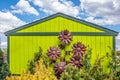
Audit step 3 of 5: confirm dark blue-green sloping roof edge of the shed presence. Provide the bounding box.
[5,12,118,36]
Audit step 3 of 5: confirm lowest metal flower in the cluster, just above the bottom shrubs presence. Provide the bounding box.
[54,62,66,79]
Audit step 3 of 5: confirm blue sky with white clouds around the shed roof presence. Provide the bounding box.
[0,0,120,50]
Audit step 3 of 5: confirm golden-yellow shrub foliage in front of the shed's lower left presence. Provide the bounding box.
[6,59,57,80]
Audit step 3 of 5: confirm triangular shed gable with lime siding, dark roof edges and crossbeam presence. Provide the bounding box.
[5,13,118,36]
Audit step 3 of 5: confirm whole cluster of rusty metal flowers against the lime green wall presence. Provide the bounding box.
[47,30,86,79]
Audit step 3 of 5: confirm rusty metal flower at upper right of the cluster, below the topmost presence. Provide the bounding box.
[72,42,86,56]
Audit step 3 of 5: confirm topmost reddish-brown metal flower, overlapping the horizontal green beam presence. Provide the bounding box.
[58,30,72,44]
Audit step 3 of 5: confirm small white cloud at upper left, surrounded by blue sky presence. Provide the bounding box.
[11,0,39,16]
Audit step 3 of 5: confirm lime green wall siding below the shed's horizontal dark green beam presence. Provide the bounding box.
[10,36,113,74]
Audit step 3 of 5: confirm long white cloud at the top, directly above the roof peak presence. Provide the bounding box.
[29,0,79,16]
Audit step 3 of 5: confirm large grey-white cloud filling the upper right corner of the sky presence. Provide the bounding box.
[80,0,120,25]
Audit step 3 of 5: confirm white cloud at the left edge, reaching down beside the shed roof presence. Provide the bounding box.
[0,11,25,48]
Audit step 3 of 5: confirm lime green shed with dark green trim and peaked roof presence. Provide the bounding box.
[5,13,118,74]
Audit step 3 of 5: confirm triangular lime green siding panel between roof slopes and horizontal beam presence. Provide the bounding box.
[18,17,104,32]
